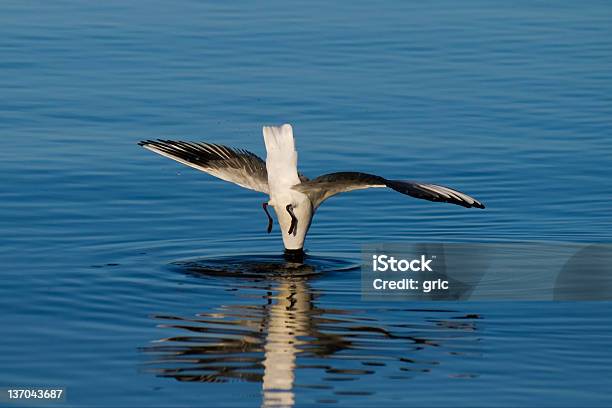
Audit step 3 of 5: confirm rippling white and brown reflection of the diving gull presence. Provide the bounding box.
[143,260,479,407]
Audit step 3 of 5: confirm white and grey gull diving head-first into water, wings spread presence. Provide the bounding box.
[138,124,485,259]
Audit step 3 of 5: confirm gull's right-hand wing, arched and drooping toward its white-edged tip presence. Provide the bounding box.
[292,172,485,208]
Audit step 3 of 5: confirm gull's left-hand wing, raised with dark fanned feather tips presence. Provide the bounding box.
[138,140,269,194]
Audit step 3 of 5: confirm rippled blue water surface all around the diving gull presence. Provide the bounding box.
[0,1,612,407]
